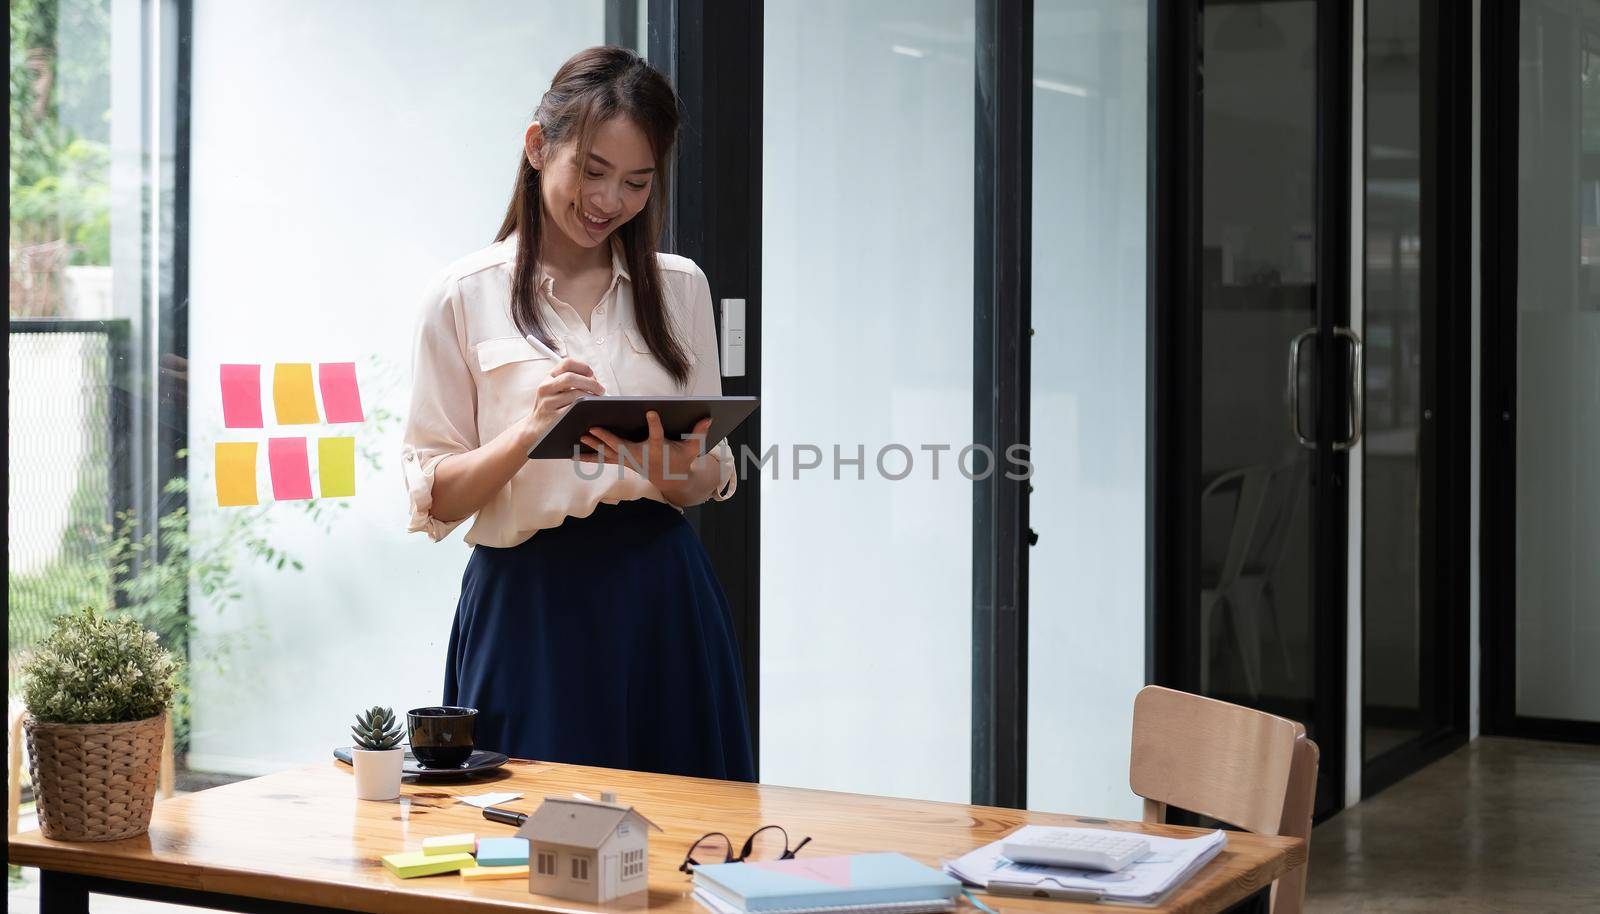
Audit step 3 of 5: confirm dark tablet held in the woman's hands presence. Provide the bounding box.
[528,397,762,459]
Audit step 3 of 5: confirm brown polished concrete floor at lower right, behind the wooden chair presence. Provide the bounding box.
[1306,738,1600,914]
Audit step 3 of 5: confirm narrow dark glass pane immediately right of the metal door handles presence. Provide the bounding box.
[1360,0,1445,760]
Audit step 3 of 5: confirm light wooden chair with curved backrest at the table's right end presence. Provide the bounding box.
[1128,685,1317,914]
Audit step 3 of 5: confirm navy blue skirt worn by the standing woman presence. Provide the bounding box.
[445,499,755,781]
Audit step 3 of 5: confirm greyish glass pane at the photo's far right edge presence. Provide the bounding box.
[1517,0,1600,720]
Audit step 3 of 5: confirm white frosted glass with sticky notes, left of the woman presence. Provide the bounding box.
[187,0,605,773]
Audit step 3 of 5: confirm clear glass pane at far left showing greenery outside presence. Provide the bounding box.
[6,0,168,745]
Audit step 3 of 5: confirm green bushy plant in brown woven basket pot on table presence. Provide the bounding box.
[21,607,178,840]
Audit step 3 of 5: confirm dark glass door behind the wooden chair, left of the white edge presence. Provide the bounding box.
[1192,0,1354,812]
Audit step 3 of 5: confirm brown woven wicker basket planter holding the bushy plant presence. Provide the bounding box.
[24,714,166,840]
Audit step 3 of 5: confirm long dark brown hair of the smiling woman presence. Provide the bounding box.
[494,48,690,384]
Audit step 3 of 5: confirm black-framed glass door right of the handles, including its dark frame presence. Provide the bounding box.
[1352,0,1470,794]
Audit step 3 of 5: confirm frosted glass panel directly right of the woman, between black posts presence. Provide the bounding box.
[761,0,973,800]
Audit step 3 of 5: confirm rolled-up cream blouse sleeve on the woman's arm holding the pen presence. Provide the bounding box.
[400,274,478,543]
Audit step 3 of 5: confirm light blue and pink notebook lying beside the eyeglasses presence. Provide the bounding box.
[694,853,962,912]
